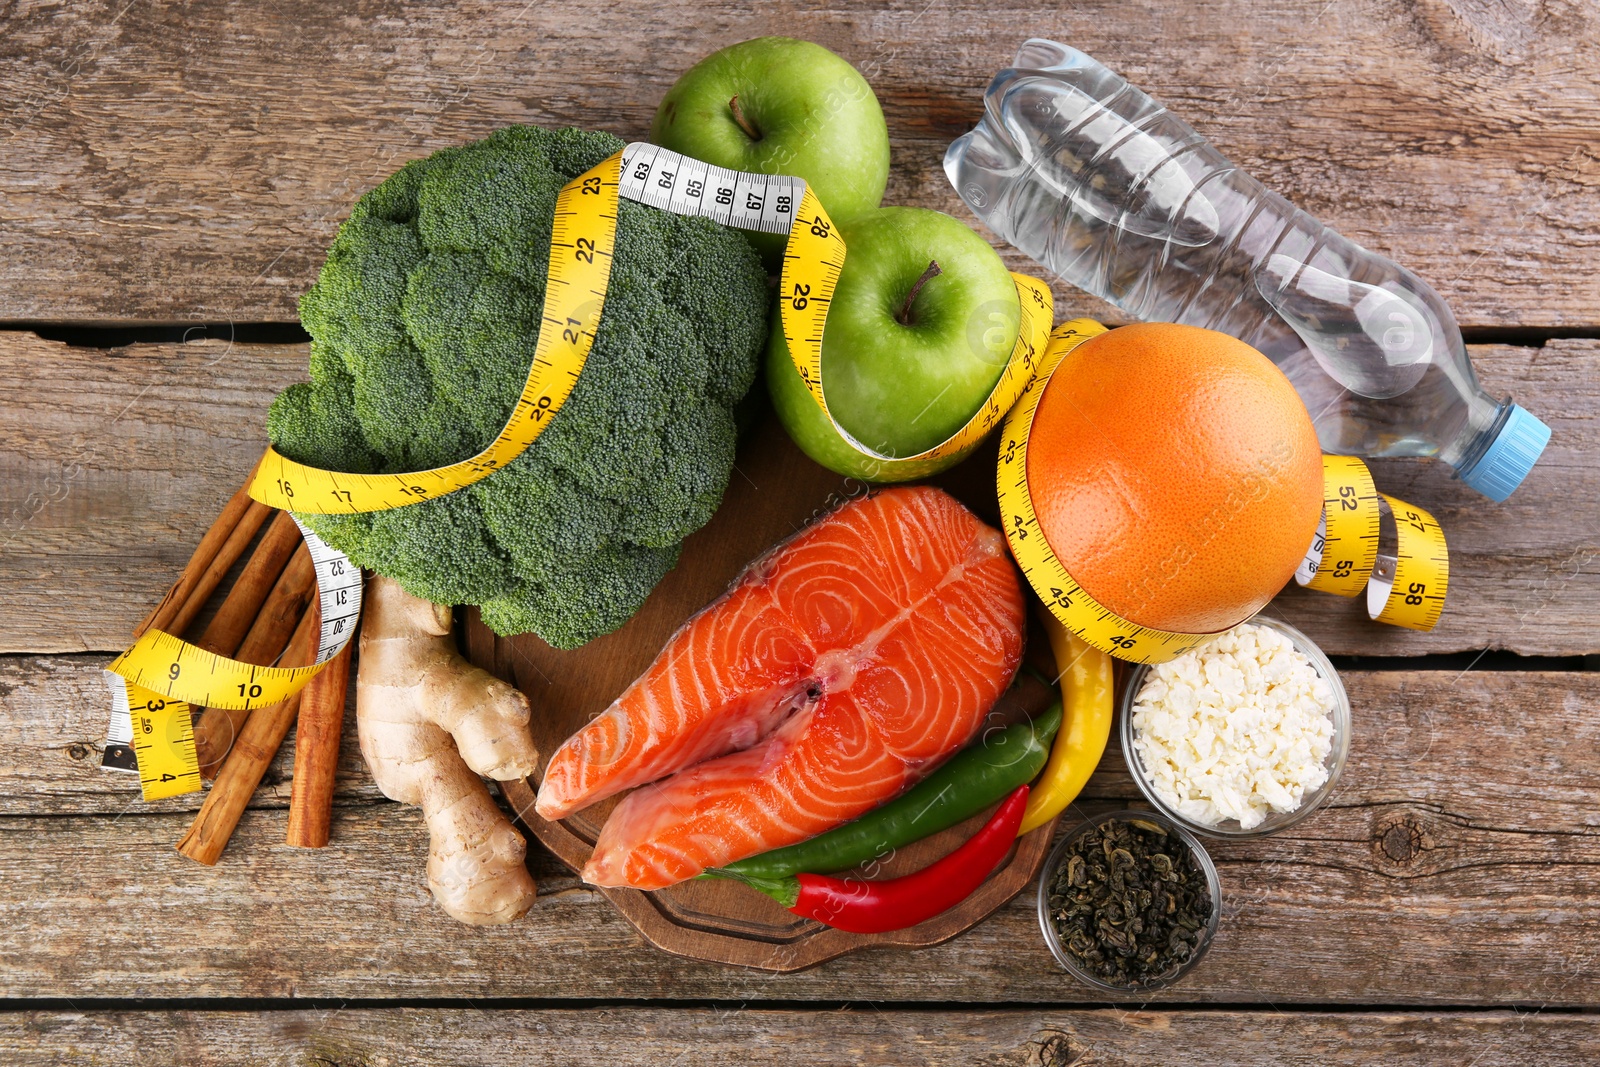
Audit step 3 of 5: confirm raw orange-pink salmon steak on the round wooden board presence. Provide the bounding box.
[536,486,1026,889]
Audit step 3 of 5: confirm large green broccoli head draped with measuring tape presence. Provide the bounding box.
[267,126,768,648]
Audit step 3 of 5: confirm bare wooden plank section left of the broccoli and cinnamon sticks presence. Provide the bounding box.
[0,333,306,651]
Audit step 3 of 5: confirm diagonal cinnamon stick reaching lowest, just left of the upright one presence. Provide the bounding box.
[178,603,322,867]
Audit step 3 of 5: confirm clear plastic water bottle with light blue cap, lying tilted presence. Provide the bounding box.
[944,38,1550,501]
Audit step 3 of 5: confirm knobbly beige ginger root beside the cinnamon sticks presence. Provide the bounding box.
[355,576,539,925]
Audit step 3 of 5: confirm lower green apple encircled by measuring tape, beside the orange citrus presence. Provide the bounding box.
[766,208,1021,482]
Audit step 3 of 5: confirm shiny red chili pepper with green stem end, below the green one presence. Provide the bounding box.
[732,785,1027,934]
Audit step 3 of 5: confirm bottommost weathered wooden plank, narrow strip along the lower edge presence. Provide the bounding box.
[0,1008,1600,1067]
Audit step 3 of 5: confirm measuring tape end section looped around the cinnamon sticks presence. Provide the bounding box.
[106,520,362,800]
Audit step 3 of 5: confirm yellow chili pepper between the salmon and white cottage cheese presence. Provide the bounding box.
[1018,611,1114,837]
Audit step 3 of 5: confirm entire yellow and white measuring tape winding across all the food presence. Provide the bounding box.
[107,137,1445,800]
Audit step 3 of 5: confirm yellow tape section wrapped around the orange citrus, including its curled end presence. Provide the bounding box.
[997,318,1450,664]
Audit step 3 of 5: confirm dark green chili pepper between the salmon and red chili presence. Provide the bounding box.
[706,701,1061,878]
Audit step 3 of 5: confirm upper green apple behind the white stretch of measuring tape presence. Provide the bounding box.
[650,37,890,270]
